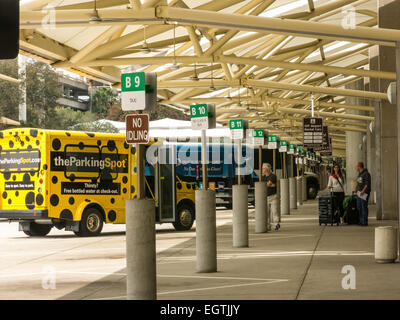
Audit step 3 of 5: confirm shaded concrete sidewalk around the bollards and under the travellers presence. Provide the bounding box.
[62,201,400,300]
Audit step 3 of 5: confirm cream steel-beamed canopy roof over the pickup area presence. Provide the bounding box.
[20,0,400,153]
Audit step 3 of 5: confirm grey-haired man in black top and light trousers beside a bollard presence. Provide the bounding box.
[262,163,280,230]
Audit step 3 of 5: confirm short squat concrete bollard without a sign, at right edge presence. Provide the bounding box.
[375,226,397,263]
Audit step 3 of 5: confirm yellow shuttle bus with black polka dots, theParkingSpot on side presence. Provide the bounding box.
[0,128,197,236]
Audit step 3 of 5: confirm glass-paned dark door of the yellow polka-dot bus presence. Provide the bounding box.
[156,145,176,222]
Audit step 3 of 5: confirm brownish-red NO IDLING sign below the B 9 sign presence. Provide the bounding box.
[125,114,149,144]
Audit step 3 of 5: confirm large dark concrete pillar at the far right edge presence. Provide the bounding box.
[369,0,400,219]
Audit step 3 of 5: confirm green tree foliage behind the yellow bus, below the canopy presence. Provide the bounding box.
[0,59,189,132]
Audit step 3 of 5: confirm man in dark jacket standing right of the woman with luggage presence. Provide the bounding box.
[355,162,371,226]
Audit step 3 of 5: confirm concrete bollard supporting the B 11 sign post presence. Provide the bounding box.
[232,184,249,248]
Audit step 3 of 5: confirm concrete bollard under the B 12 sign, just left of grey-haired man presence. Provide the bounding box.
[254,182,269,233]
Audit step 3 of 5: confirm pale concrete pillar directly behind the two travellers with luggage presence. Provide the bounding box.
[346,79,365,194]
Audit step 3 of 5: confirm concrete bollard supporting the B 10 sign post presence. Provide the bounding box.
[196,190,217,272]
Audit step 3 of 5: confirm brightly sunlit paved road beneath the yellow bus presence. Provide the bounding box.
[0,210,231,300]
